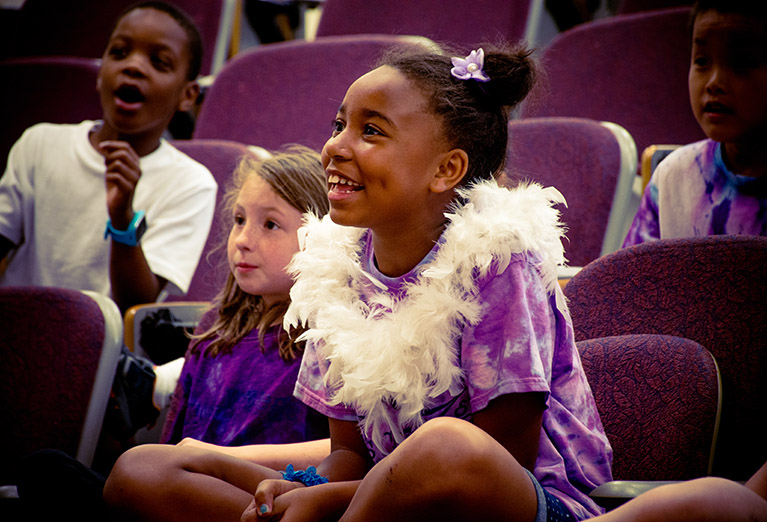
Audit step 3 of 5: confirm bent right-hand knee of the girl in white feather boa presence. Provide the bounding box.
[341,417,537,522]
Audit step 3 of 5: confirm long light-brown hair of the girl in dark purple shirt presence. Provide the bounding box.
[191,145,329,361]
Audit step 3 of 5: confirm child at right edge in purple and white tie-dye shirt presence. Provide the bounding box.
[623,0,767,246]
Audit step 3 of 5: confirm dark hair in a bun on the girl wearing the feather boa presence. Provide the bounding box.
[379,45,536,184]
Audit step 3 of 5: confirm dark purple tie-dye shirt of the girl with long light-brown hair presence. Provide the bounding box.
[162,326,327,446]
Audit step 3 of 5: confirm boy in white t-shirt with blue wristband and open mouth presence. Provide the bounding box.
[0,2,217,311]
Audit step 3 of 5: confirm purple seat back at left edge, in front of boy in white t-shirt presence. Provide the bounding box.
[0,287,123,485]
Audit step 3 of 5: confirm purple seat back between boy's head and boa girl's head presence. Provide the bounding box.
[194,35,433,151]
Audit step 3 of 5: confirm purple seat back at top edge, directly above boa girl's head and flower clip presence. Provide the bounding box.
[317,0,533,47]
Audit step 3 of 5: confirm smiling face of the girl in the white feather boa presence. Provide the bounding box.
[322,67,456,235]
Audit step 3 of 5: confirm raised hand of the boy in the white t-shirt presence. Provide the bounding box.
[99,140,141,226]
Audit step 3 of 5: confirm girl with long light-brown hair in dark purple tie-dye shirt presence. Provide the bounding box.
[162,147,328,446]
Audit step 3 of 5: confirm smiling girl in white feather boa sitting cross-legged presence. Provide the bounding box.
[105,41,612,522]
